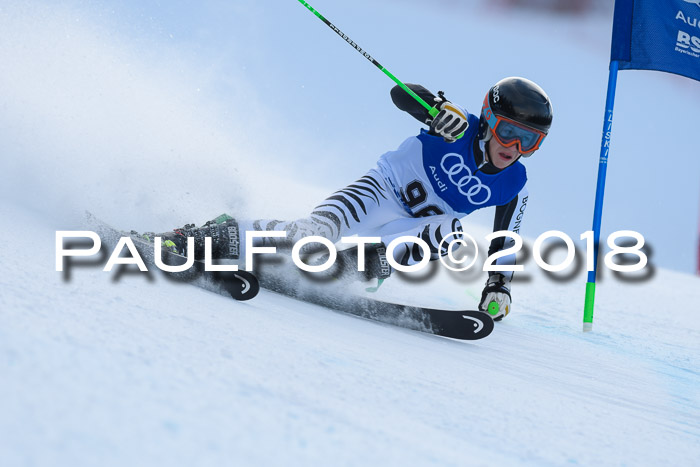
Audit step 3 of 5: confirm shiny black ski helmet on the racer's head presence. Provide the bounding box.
[479,76,552,150]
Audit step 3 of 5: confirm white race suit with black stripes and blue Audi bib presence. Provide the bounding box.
[241,85,528,276]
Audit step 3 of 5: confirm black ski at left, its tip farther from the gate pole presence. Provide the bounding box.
[86,212,260,301]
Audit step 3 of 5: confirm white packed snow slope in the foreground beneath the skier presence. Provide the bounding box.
[0,191,700,466]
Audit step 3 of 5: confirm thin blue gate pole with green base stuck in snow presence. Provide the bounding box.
[583,60,618,332]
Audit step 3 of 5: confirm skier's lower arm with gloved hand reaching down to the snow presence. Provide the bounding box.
[479,187,528,321]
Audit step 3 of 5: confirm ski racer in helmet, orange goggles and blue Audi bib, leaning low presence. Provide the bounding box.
[153,77,552,320]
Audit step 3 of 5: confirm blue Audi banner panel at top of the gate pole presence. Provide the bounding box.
[610,0,700,81]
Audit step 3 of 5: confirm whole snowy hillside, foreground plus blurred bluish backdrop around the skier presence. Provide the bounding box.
[0,0,700,466]
